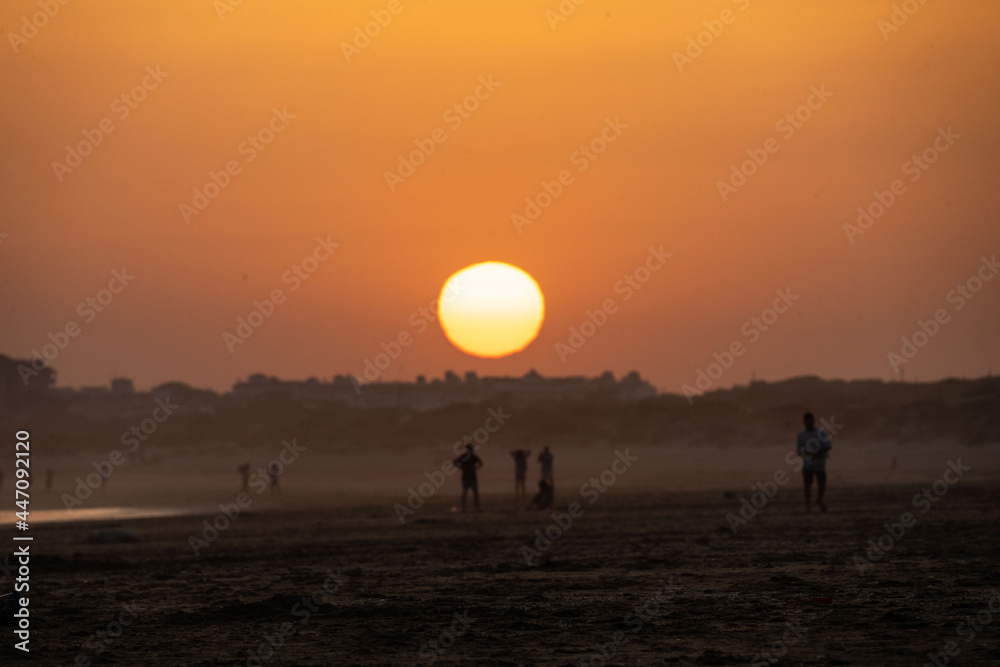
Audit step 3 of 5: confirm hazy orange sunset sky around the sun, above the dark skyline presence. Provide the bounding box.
[0,0,1000,392]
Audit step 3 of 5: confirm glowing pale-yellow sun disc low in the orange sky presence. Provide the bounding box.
[438,262,545,358]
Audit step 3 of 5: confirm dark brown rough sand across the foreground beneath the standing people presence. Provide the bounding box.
[0,479,1000,665]
